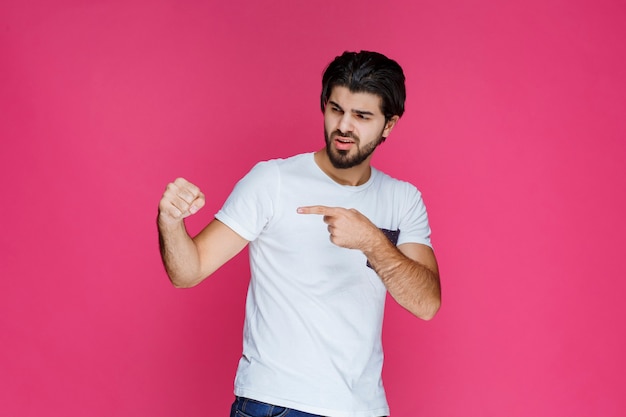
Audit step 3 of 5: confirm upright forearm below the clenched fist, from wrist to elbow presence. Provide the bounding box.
[157,219,202,288]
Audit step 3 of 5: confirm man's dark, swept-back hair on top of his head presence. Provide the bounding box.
[321,51,406,120]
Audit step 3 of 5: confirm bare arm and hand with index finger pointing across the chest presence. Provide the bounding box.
[298,206,441,320]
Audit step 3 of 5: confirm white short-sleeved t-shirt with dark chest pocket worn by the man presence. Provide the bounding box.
[216,153,430,417]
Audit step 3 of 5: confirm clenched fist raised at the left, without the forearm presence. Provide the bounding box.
[159,178,205,225]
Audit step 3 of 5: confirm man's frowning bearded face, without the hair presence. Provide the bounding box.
[324,86,398,169]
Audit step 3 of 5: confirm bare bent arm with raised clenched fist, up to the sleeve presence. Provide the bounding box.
[157,178,248,288]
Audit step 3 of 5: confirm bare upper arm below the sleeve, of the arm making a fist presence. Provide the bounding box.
[193,219,248,277]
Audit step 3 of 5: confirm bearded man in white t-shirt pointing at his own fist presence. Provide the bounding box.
[158,51,440,417]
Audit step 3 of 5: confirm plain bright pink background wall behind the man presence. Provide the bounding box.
[0,0,626,417]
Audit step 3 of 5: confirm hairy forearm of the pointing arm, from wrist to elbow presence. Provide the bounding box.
[364,236,441,320]
